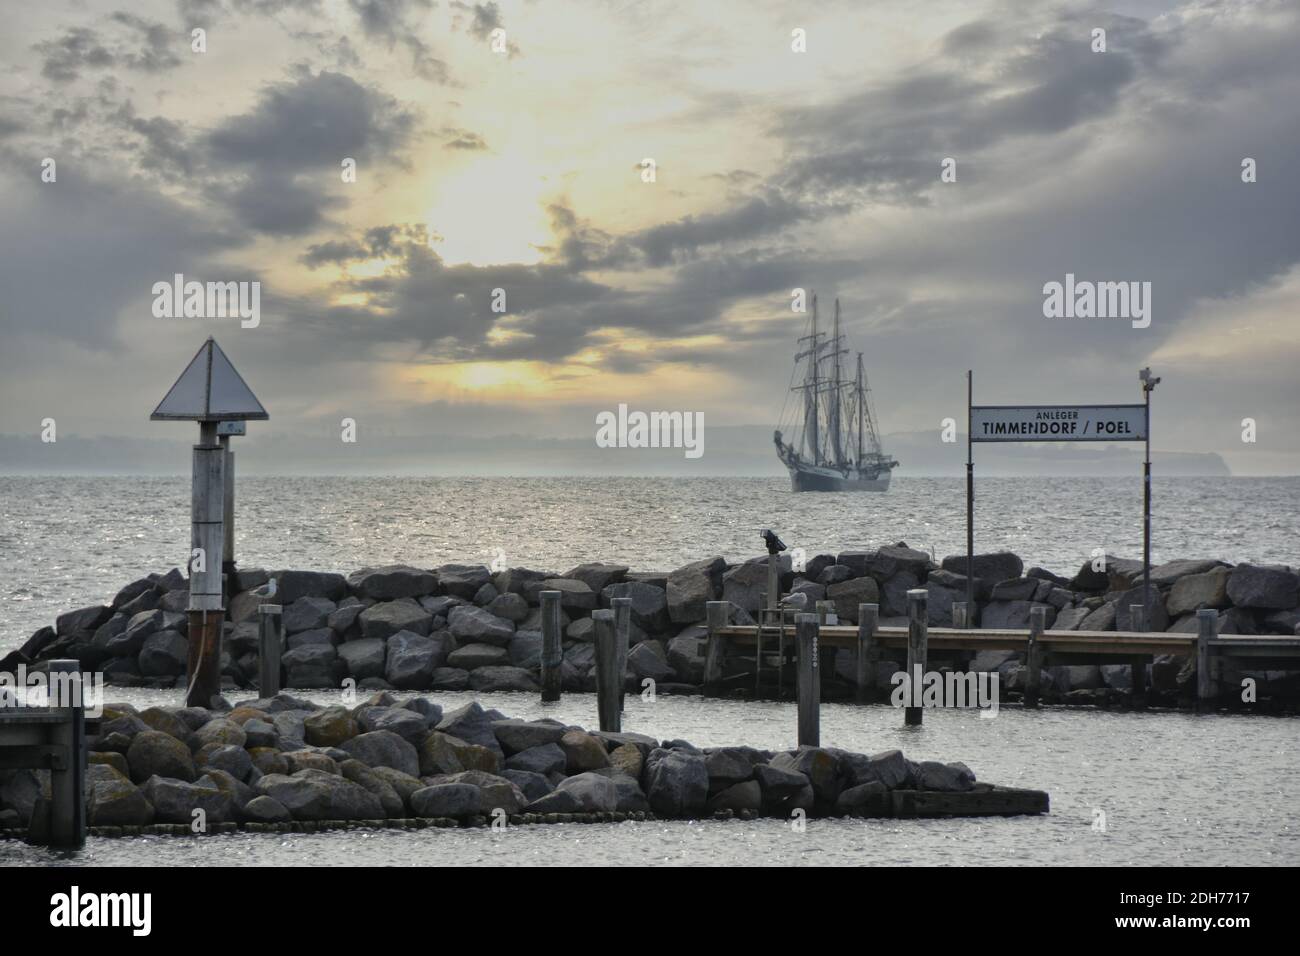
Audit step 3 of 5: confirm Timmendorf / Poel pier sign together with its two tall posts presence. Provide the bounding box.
[966,377,1160,627]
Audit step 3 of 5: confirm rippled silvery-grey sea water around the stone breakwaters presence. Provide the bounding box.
[0,477,1300,865]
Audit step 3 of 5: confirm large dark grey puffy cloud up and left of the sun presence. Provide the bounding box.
[204,70,415,235]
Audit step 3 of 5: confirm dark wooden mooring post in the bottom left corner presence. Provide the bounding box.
[49,661,86,849]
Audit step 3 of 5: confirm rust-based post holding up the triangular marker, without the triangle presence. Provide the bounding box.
[185,421,226,708]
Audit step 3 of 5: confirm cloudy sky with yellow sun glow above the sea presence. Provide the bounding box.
[0,0,1300,473]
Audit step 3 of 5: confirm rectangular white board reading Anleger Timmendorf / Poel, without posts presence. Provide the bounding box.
[970,405,1147,441]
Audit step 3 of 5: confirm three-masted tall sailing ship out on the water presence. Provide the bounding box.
[774,295,898,492]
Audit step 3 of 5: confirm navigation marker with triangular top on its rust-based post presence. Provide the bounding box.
[150,337,269,708]
